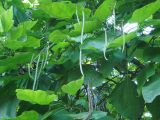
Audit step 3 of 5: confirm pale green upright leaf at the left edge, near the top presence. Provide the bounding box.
[0,7,13,32]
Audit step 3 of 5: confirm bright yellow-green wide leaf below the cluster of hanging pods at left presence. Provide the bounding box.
[16,89,58,105]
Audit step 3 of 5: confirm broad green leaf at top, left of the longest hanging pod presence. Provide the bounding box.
[39,2,76,19]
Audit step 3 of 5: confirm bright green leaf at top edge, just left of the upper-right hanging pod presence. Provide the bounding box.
[93,0,115,21]
